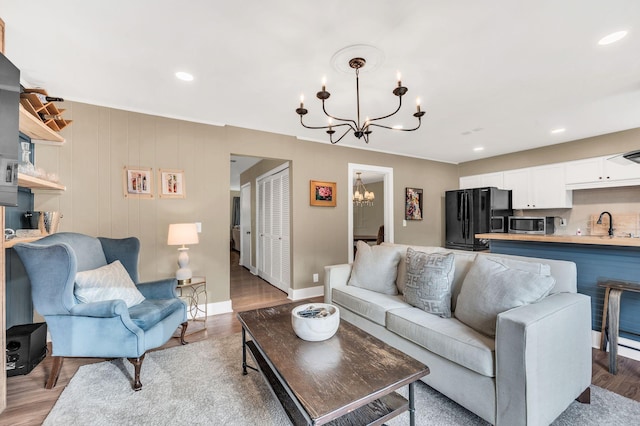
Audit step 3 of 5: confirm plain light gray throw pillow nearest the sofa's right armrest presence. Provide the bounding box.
[454,256,556,337]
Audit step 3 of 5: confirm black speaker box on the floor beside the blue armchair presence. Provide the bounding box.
[6,322,47,377]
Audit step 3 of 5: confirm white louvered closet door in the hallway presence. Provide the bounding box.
[258,169,291,292]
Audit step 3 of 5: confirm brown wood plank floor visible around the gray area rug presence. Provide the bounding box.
[0,252,640,426]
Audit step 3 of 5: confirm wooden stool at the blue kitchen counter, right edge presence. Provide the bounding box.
[598,281,640,374]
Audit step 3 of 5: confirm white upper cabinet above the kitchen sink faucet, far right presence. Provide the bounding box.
[565,155,640,189]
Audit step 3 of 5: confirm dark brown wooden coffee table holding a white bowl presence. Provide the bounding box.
[238,303,429,426]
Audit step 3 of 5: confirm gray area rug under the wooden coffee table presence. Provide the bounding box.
[43,334,640,426]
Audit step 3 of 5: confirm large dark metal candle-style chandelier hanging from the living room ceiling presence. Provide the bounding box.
[296,58,424,144]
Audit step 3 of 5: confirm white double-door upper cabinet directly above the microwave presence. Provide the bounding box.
[504,164,573,210]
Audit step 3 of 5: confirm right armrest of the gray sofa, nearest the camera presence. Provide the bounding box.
[496,293,591,425]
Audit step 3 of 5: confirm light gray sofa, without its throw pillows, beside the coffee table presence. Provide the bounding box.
[324,243,591,426]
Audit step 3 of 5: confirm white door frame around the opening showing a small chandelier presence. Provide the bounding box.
[347,163,393,263]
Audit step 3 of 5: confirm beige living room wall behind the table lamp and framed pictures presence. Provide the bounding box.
[35,102,458,302]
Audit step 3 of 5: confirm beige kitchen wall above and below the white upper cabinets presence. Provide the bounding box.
[459,129,640,235]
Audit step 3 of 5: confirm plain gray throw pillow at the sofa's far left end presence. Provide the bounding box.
[347,241,400,295]
